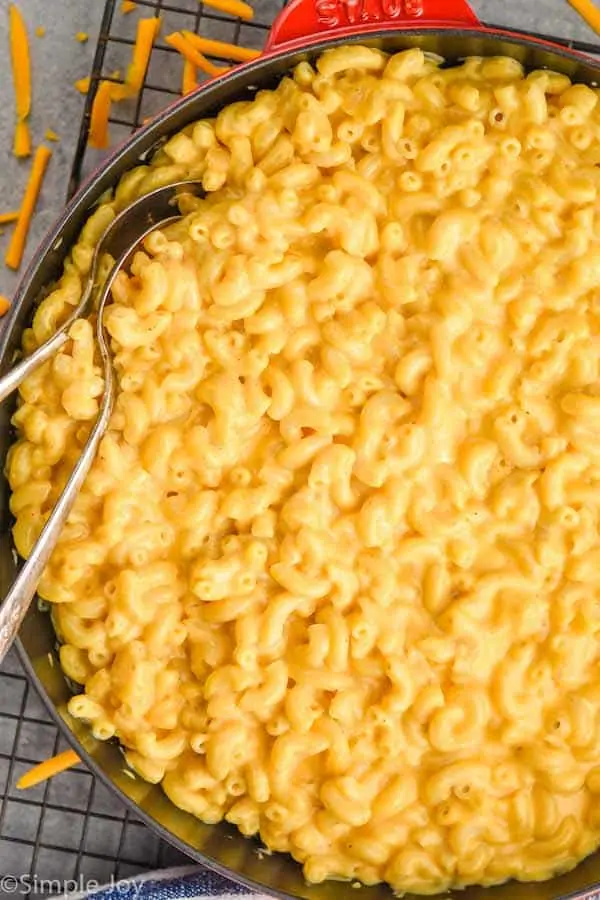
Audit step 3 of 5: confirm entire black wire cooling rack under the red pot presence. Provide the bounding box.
[0,0,598,898]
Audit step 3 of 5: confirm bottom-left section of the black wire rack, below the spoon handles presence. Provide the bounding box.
[0,651,189,884]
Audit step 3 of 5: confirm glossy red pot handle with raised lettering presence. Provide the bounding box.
[265,0,481,51]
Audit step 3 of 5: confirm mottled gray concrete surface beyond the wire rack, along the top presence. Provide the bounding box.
[0,0,600,296]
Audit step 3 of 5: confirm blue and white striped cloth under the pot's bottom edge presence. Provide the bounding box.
[54,866,269,900]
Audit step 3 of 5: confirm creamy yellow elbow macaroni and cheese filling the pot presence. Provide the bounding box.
[8,46,600,894]
